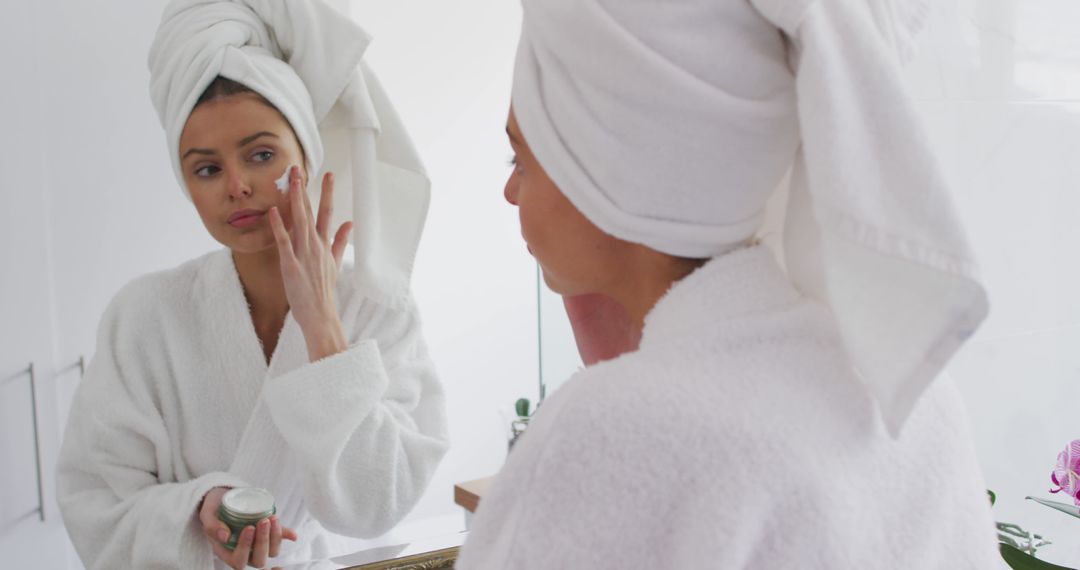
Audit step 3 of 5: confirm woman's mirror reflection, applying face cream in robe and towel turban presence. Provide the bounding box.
[57,0,447,569]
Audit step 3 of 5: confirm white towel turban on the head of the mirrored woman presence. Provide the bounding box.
[149,0,430,304]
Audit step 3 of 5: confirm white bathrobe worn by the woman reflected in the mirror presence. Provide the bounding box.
[57,249,447,570]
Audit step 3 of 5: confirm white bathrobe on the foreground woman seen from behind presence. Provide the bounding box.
[457,246,1000,570]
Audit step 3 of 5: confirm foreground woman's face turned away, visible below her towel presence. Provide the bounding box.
[504,109,634,296]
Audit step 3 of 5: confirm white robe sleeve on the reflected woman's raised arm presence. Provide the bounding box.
[264,293,448,538]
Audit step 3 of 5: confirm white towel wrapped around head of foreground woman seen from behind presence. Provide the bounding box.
[513,0,987,434]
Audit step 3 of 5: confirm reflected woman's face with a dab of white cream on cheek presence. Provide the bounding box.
[180,93,307,254]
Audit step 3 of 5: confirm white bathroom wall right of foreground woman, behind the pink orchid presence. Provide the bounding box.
[909,0,1080,568]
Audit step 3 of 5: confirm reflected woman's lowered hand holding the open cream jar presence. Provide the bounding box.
[199,487,297,570]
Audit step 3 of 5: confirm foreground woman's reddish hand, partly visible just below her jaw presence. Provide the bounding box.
[563,294,642,366]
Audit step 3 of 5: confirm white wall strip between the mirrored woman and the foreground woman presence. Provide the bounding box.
[346,0,539,537]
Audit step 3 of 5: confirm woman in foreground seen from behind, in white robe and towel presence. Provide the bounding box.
[457,0,1000,570]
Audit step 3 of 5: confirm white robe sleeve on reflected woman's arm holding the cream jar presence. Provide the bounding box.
[56,288,246,570]
